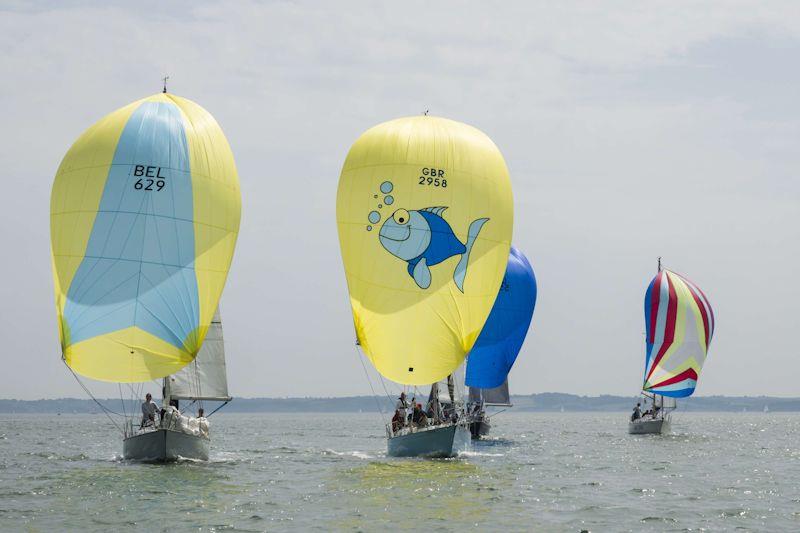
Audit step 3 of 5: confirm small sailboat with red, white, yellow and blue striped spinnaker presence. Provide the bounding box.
[628,257,715,434]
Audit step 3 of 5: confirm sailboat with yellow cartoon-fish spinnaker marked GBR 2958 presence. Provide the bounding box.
[336,115,513,457]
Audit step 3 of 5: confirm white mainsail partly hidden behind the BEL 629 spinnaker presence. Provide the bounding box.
[167,309,231,402]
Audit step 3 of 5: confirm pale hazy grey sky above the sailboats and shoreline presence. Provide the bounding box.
[0,1,800,399]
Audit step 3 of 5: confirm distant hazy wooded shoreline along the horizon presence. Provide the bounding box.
[0,392,800,414]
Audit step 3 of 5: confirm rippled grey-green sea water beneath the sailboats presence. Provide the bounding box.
[0,411,800,532]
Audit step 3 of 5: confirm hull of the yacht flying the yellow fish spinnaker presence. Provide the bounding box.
[387,424,470,458]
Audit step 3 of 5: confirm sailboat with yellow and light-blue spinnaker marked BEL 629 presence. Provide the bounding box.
[50,87,241,461]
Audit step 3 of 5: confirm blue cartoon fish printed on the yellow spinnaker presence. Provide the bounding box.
[378,207,489,293]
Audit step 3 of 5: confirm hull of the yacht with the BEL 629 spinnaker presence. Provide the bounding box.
[122,429,211,462]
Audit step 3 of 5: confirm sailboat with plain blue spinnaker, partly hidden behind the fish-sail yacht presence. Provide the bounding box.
[466,246,536,439]
